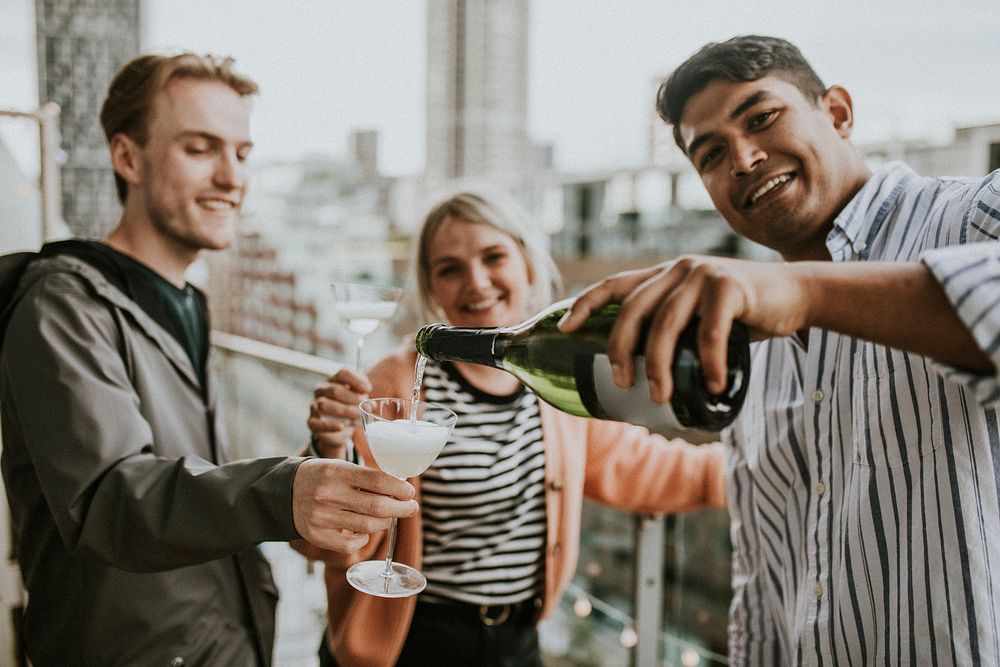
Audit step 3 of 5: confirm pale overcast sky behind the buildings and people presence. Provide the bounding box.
[0,0,1000,174]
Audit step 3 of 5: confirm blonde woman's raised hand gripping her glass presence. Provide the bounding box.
[306,368,372,459]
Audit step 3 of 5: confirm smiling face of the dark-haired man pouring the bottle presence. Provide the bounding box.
[678,75,870,260]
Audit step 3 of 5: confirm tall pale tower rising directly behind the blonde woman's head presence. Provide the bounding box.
[425,0,534,186]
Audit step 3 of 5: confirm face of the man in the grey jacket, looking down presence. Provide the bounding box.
[122,78,252,254]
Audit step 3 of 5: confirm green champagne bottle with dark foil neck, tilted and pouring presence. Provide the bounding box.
[416,300,750,433]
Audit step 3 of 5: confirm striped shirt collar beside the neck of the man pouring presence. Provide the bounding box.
[826,162,916,260]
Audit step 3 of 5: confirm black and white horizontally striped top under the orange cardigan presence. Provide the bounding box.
[420,361,545,604]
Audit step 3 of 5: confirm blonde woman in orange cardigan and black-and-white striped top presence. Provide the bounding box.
[298,191,725,667]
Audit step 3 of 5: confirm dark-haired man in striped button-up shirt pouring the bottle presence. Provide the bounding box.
[563,36,1000,665]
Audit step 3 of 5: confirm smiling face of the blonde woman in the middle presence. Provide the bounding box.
[427,217,531,327]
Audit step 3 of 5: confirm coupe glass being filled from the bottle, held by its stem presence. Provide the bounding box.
[347,398,458,598]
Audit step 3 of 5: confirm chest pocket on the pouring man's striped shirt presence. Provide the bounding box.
[851,343,941,468]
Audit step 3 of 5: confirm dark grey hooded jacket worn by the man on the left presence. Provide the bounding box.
[0,255,302,667]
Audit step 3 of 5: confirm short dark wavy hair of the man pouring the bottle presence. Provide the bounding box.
[656,35,826,150]
